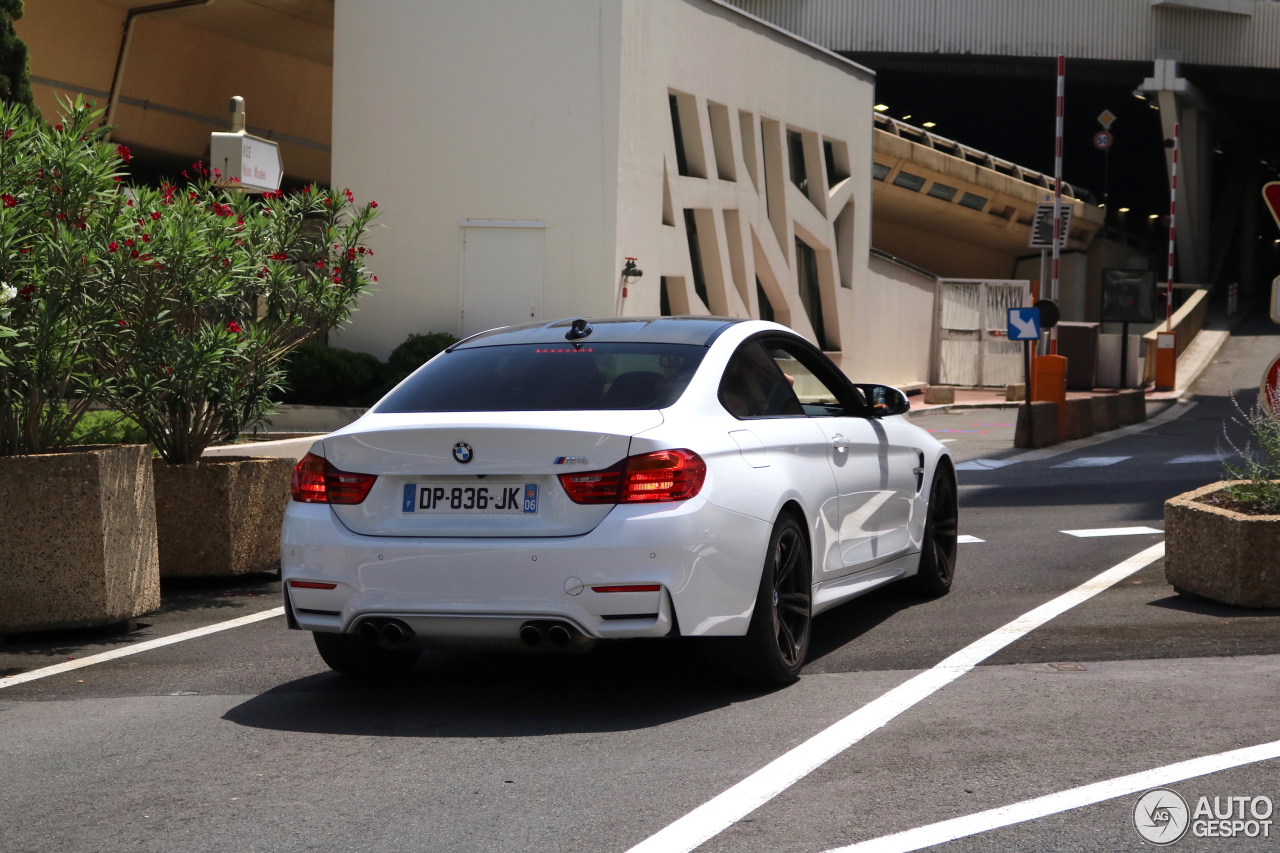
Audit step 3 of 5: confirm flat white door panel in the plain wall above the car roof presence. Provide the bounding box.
[460,220,543,337]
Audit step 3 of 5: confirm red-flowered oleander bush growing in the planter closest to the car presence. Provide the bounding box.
[108,164,375,464]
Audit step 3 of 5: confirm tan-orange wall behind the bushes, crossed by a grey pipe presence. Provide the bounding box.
[17,0,333,182]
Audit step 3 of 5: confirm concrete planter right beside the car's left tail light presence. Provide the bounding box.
[155,456,293,578]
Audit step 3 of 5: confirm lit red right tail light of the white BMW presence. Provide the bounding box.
[559,450,707,503]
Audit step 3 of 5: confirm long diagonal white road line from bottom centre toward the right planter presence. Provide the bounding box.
[627,542,1165,853]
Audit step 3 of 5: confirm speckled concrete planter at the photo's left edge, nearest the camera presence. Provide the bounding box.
[0,444,160,634]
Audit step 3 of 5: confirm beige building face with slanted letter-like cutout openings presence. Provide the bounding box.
[611,0,875,373]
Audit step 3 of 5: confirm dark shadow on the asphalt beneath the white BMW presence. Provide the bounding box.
[223,639,762,738]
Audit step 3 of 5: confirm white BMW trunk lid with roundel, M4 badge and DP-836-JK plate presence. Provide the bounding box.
[323,410,662,538]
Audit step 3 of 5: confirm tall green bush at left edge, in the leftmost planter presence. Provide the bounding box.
[0,100,124,456]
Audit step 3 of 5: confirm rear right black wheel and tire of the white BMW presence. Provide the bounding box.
[722,515,813,688]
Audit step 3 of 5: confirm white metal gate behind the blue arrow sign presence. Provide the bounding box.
[936,278,1032,387]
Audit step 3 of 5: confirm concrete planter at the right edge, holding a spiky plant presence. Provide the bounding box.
[1165,480,1280,607]
